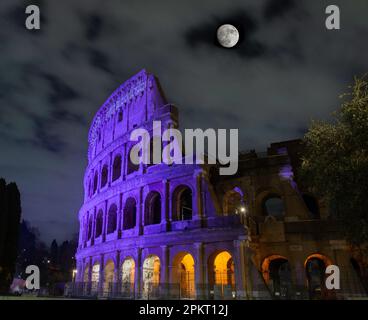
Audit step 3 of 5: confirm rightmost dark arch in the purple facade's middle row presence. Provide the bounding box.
[172,185,193,221]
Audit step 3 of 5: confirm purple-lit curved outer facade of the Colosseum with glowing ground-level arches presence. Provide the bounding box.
[76,70,247,297]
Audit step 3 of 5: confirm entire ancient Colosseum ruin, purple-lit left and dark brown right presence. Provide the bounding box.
[72,70,364,299]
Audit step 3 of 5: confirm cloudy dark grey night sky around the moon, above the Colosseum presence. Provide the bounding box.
[0,0,368,241]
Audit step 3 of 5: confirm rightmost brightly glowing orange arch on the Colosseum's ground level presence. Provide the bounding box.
[208,250,235,299]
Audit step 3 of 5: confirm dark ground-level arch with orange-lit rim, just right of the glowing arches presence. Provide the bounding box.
[261,254,292,298]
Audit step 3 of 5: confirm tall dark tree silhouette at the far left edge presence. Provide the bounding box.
[0,179,21,293]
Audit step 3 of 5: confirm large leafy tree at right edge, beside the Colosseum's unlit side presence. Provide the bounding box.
[301,76,368,248]
